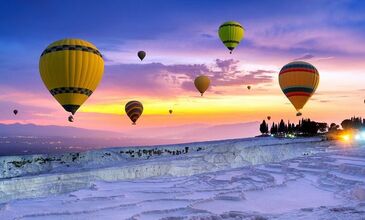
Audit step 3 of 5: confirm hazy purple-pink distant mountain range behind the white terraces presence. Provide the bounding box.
[0,122,259,155]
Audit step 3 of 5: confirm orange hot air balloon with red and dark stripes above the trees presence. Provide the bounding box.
[279,61,319,116]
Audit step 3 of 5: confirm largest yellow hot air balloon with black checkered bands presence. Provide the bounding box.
[39,39,104,114]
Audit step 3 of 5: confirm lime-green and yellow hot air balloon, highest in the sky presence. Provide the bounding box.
[218,21,245,53]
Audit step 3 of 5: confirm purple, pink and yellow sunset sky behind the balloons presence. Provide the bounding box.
[0,0,365,136]
